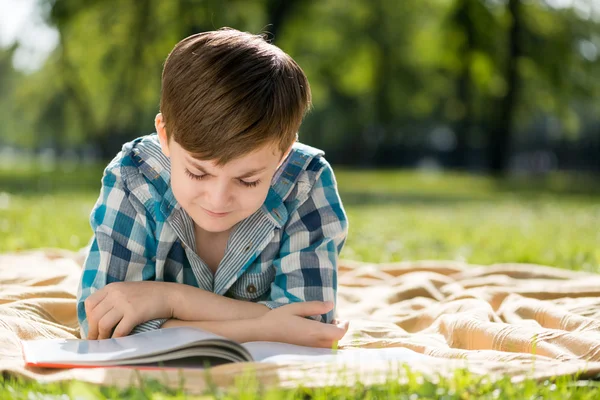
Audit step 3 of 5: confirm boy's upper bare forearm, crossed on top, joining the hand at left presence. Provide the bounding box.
[166,283,270,321]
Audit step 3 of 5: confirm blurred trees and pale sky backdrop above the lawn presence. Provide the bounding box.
[0,0,600,172]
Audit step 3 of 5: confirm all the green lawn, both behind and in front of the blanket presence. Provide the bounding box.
[0,163,600,399]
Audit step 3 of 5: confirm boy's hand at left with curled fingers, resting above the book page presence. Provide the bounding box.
[84,281,173,340]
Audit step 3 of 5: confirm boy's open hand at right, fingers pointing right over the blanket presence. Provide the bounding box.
[258,301,348,348]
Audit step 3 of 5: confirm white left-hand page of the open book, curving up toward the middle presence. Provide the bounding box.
[23,327,232,364]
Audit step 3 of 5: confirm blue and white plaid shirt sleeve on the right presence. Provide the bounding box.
[260,159,348,323]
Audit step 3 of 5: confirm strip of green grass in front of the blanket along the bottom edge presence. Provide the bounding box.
[0,367,600,400]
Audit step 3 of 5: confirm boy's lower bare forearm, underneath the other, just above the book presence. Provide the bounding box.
[162,319,270,343]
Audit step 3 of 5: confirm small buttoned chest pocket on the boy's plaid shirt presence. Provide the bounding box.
[227,264,275,301]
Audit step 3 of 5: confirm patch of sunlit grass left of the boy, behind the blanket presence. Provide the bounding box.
[0,162,102,251]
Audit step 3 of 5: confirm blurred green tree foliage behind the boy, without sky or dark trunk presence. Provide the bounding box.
[0,0,600,162]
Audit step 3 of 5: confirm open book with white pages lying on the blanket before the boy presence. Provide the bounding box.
[21,327,433,368]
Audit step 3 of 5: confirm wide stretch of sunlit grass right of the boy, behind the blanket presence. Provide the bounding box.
[338,171,600,272]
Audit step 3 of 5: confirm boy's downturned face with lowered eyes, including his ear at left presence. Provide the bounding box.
[156,114,284,233]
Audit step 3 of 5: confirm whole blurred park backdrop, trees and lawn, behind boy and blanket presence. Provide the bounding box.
[0,0,600,270]
